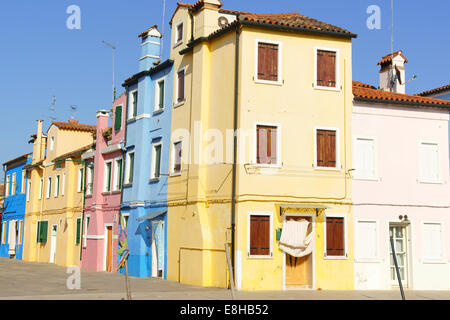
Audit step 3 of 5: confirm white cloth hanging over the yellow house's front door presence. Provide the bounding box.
[279,219,313,258]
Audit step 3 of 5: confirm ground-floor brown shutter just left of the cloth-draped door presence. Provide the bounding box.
[250,215,270,255]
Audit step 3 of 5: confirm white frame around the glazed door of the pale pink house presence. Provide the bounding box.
[387,220,413,289]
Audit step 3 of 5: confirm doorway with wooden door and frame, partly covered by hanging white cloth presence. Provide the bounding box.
[284,214,315,289]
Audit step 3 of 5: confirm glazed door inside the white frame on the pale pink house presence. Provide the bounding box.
[388,224,408,287]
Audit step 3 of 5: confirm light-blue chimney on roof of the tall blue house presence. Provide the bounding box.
[139,25,162,72]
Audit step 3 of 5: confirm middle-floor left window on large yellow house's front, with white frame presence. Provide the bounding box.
[256,124,280,165]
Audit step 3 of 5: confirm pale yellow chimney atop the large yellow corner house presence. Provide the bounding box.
[193,0,222,38]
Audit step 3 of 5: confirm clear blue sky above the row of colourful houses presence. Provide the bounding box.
[0,0,450,176]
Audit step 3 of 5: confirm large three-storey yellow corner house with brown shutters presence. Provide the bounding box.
[167,0,356,290]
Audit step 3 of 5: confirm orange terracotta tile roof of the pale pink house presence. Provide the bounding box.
[353,81,450,108]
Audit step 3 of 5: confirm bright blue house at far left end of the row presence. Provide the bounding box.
[0,153,32,259]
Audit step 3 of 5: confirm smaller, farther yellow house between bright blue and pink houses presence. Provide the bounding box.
[23,120,96,266]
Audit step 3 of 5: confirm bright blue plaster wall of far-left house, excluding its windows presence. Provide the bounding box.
[0,155,32,260]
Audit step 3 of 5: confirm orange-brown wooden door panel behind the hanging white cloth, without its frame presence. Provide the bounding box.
[286,217,312,286]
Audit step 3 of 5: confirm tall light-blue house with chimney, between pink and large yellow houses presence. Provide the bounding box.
[119,26,173,279]
